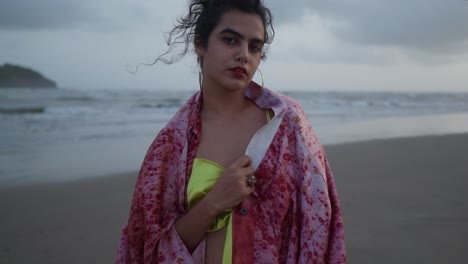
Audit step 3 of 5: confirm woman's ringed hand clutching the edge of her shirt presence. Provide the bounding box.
[205,155,255,212]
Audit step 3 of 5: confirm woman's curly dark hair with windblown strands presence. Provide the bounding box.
[128,0,275,70]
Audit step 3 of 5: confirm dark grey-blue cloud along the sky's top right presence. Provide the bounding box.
[268,0,468,56]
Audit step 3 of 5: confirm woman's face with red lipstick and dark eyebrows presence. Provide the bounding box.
[196,10,265,91]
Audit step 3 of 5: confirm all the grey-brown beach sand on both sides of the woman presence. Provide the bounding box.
[0,134,468,264]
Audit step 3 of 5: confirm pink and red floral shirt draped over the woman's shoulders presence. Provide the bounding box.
[116,83,346,264]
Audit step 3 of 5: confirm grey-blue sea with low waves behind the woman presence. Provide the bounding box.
[0,88,468,187]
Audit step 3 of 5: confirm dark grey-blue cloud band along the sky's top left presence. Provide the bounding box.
[0,0,165,31]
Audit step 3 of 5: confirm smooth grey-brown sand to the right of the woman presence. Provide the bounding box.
[326,134,468,264]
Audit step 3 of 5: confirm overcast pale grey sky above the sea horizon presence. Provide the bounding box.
[0,0,468,92]
